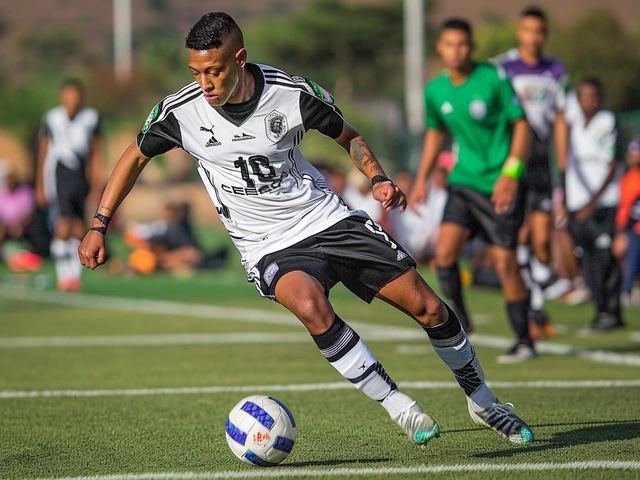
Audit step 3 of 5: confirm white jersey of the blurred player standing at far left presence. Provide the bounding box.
[40,105,100,200]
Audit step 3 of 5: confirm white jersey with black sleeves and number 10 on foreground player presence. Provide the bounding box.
[138,64,366,281]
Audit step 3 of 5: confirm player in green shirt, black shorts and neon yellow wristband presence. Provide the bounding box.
[409,19,536,363]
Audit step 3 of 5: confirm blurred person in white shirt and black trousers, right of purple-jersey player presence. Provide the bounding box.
[558,78,623,332]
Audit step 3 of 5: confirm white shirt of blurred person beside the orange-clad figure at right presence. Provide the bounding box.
[565,106,622,212]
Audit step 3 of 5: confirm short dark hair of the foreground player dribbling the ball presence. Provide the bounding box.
[185,12,244,50]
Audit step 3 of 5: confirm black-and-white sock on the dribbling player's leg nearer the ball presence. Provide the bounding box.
[312,315,413,418]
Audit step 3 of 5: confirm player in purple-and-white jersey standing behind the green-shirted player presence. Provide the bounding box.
[493,7,571,337]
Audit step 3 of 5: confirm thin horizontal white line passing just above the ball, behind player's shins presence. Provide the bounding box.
[0,380,640,400]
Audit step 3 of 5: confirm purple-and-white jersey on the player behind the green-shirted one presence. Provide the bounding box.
[492,48,569,142]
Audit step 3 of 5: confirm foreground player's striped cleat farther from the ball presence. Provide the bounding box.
[467,397,533,445]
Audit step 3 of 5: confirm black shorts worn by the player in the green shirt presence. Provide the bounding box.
[442,185,524,249]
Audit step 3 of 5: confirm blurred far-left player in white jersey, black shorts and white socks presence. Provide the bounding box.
[36,79,103,291]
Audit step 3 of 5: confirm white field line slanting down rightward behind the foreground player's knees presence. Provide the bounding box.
[0,285,640,367]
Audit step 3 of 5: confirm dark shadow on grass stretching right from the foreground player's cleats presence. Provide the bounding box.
[474,420,640,458]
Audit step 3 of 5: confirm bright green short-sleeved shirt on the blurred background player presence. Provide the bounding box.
[425,63,525,193]
